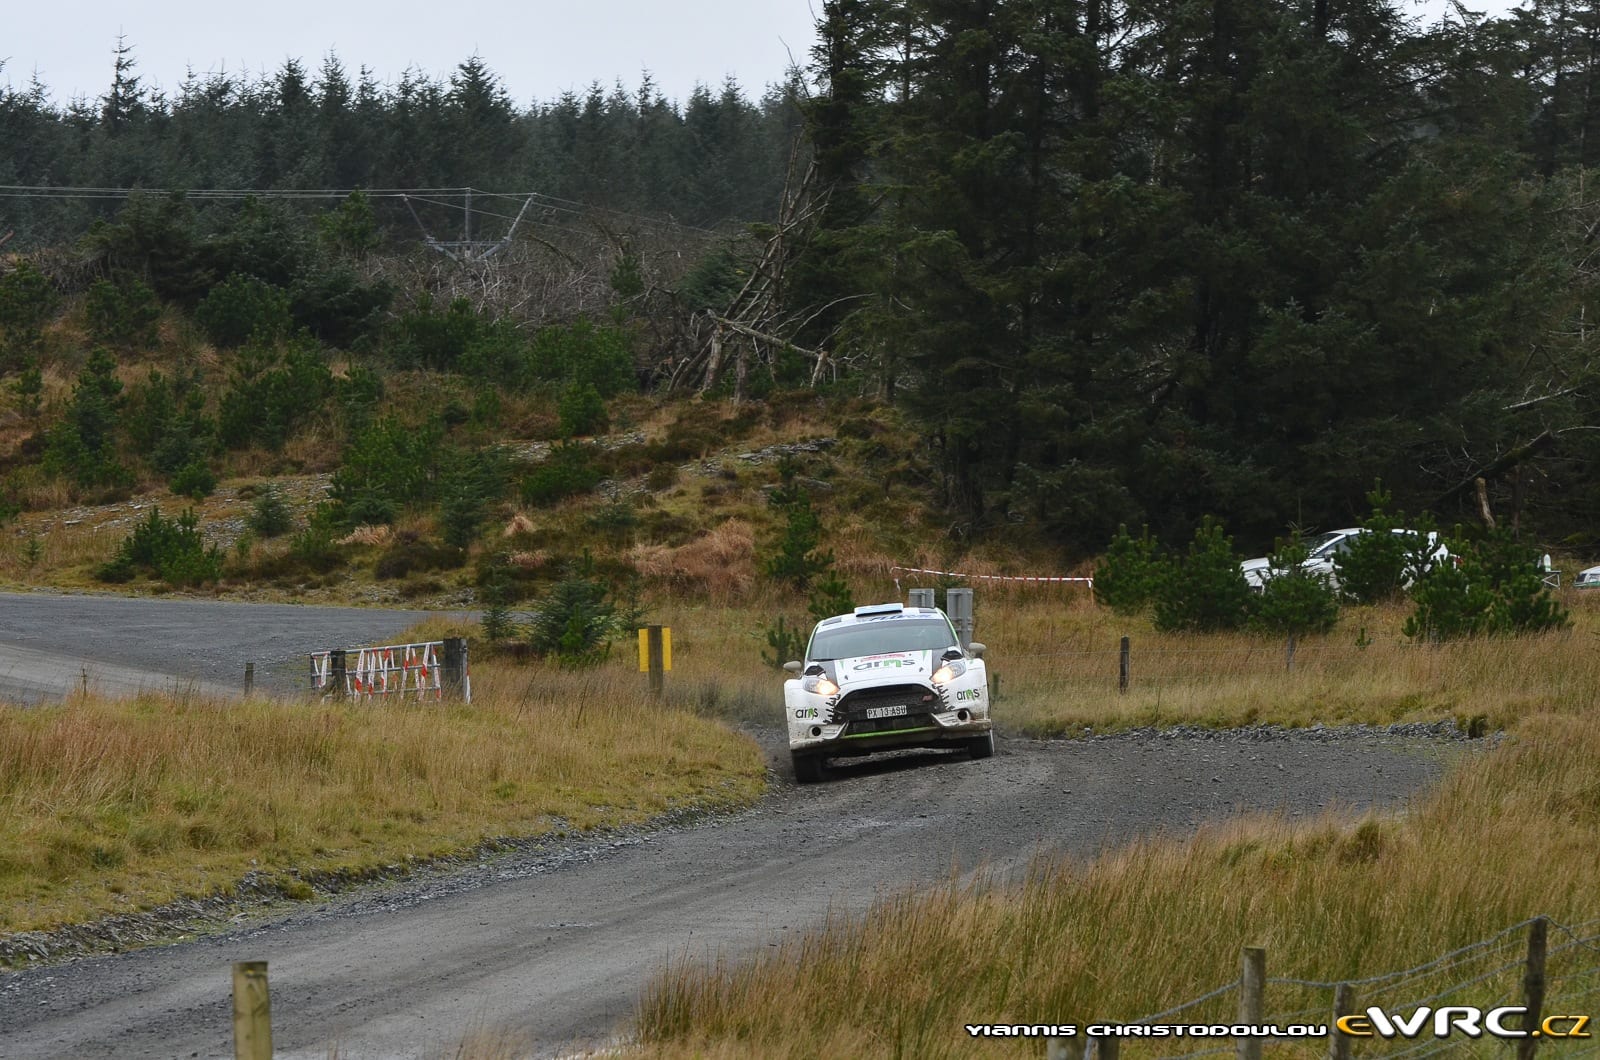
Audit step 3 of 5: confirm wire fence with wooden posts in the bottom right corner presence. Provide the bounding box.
[1046,916,1600,1060]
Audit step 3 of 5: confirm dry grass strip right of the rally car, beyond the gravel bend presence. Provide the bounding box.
[978,589,1600,735]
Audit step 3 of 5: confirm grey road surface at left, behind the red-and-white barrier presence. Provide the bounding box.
[0,592,444,703]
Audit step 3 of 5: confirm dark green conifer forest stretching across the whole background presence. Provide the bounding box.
[0,0,1600,557]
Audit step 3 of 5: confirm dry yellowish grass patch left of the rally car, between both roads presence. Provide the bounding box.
[0,665,763,932]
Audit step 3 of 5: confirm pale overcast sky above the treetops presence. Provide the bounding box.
[0,0,1512,107]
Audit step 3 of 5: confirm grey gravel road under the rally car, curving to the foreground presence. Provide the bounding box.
[0,725,1472,1060]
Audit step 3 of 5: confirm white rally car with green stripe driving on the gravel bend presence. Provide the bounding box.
[784,604,995,783]
